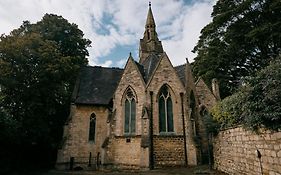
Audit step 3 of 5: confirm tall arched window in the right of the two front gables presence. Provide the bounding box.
[158,85,174,132]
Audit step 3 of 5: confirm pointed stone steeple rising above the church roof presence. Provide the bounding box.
[139,2,164,64]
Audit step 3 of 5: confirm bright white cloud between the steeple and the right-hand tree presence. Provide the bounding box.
[162,1,213,65]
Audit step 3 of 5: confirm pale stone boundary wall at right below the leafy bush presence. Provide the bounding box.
[213,127,281,175]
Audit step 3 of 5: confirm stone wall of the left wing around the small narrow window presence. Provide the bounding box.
[57,105,108,169]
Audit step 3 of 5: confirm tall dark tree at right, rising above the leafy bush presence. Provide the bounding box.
[193,0,281,97]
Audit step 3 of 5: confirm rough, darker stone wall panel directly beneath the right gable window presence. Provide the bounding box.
[153,136,185,168]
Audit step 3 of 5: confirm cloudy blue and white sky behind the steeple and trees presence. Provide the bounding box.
[0,0,216,67]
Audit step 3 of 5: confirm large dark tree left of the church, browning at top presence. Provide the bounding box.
[0,14,91,171]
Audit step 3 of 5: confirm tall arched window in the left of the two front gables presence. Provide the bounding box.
[124,88,136,134]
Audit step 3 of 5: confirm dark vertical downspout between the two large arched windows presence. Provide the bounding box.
[149,91,154,170]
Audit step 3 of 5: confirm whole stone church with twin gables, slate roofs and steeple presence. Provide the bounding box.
[57,6,220,169]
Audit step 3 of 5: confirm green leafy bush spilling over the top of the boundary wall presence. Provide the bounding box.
[211,56,281,130]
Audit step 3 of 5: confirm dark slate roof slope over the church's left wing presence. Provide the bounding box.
[72,66,123,105]
